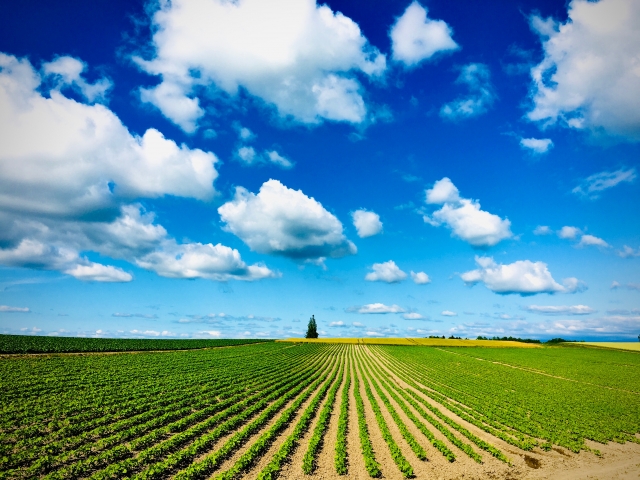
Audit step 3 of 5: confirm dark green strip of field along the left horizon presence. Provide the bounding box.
[0,335,273,353]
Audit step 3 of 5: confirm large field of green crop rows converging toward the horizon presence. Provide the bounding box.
[0,342,640,480]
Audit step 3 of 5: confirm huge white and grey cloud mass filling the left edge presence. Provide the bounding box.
[0,54,272,288]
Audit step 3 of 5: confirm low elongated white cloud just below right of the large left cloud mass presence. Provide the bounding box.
[136,241,279,281]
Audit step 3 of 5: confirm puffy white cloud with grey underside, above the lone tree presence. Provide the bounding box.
[218,180,357,260]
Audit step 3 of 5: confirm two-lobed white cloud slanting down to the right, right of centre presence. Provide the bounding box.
[423,177,513,248]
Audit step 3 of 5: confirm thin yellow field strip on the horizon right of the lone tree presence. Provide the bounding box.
[276,338,541,348]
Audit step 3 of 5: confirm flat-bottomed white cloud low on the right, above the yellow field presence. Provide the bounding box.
[460,256,585,296]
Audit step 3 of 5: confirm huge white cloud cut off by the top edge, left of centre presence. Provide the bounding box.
[134,0,386,131]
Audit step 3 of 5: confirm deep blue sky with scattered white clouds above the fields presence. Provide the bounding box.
[0,0,640,340]
